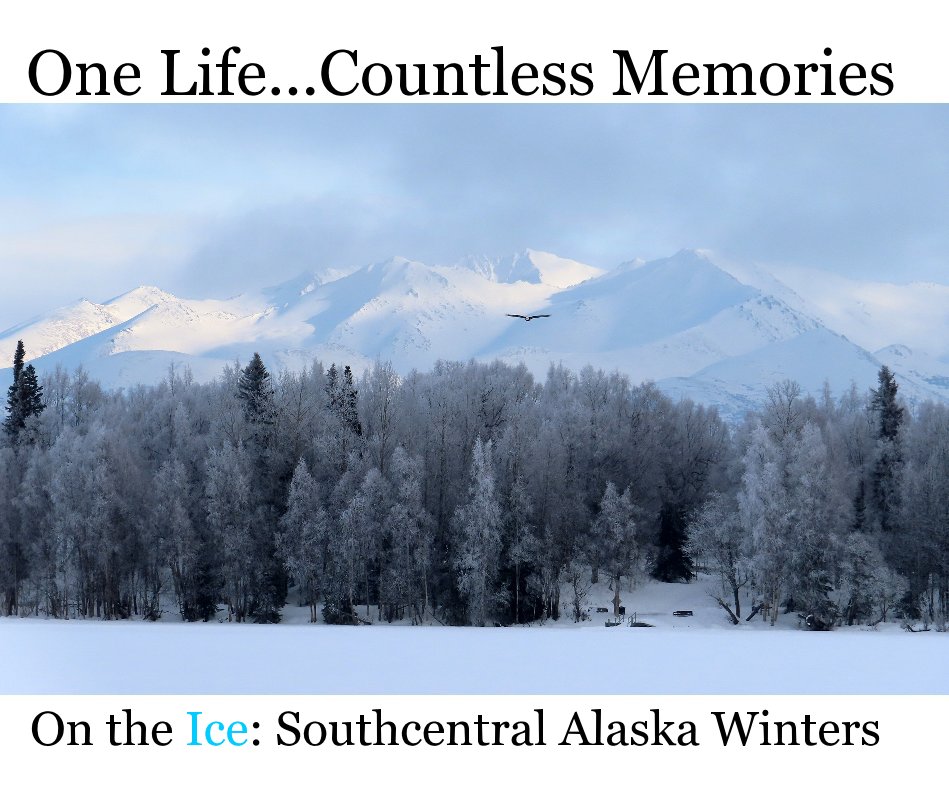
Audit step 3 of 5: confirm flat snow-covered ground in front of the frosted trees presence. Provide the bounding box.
[0,582,949,694]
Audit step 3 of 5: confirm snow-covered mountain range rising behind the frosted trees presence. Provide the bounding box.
[0,250,949,412]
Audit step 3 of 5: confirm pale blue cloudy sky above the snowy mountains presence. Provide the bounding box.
[0,104,949,330]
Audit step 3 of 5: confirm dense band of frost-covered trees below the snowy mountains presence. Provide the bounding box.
[0,334,949,628]
